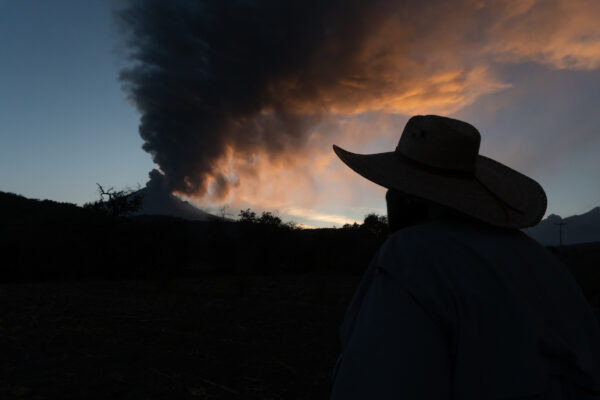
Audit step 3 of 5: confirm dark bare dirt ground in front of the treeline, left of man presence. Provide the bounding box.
[0,275,360,400]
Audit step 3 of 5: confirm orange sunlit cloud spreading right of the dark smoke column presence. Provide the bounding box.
[176,0,600,225]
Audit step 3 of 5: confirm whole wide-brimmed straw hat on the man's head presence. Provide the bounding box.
[333,115,547,228]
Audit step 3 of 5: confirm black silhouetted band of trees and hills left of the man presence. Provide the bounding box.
[0,191,387,282]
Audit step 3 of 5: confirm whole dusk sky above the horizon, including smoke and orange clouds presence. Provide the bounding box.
[0,0,600,226]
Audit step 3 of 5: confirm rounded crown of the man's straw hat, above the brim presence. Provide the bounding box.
[396,115,481,174]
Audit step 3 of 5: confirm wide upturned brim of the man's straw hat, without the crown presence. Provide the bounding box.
[333,145,547,229]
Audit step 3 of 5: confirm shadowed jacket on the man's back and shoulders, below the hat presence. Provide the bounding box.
[331,218,600,400]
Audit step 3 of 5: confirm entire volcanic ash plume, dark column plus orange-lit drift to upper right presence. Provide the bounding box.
[116,0,598,206]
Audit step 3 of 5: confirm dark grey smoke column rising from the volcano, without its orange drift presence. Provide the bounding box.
[118,0,380,198]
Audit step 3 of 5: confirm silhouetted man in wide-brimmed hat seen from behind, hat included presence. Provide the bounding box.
[331,115,600,400]
